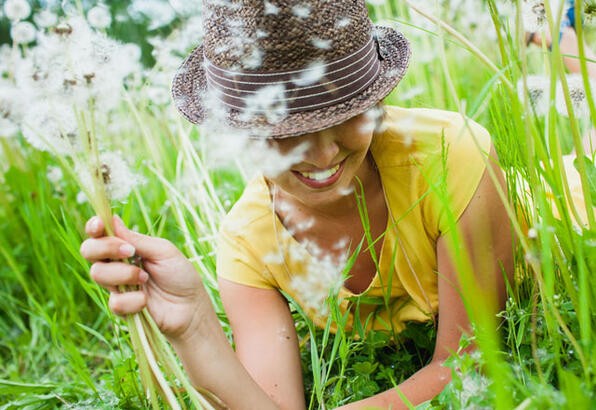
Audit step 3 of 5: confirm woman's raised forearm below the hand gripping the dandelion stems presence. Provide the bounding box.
[170,306,277,409]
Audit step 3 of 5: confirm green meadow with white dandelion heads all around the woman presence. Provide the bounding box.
[0,0,596,410]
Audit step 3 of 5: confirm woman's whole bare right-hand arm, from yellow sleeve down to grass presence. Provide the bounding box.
[341,148,513,410]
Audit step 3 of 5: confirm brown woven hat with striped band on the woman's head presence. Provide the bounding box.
[172,0,410,138]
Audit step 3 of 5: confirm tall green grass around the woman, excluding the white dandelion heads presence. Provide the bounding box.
[0,0,596,409]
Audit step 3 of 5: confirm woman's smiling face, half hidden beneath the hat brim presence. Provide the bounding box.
[269,114,374,207]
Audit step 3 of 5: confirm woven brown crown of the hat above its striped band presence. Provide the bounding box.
[203,0,372,73]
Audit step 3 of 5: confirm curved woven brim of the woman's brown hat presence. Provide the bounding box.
[172,26,411,138]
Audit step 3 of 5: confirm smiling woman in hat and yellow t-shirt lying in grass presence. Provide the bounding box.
[81,1,512,409]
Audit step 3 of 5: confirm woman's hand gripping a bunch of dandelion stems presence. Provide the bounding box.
[81,216,205,339]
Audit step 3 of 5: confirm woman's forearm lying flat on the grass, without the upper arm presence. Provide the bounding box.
[340,361,451,410]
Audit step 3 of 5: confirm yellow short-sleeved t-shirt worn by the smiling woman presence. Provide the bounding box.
[217,107,491,333]
